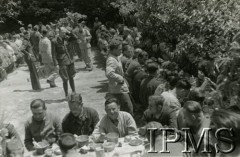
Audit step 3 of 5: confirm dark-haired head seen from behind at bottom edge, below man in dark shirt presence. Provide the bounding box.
[58,133,80,157]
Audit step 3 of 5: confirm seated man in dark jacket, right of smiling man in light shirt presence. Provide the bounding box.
[142,95,177,128]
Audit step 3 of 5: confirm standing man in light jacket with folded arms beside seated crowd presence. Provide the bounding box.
[106,37,133,115]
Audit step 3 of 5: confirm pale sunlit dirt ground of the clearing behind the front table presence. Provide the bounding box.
[0,47,107,140]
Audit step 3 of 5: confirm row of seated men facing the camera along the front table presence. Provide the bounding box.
[1,93,240,156]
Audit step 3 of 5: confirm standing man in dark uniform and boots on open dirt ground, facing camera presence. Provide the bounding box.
[52,27,76,97]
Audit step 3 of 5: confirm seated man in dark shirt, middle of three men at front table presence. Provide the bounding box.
[62,93,99,135]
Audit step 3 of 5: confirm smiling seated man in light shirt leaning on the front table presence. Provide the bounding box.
[93,98,137,139]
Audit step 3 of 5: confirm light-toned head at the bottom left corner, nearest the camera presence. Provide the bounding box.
[6,139,24,157]
